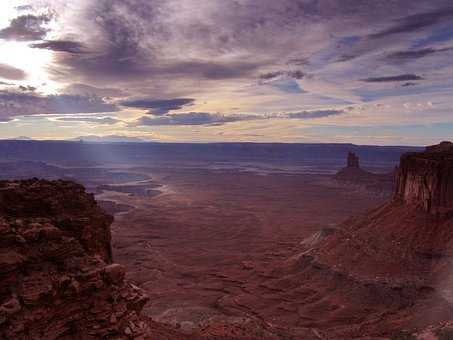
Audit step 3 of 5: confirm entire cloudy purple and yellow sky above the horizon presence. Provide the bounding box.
[0,0,453,145]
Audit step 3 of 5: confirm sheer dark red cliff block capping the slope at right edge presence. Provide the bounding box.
[395,142,453,216]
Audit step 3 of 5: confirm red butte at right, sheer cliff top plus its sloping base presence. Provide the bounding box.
[292,143,453,339]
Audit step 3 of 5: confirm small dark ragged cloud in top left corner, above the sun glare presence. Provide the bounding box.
[0,14,50,41]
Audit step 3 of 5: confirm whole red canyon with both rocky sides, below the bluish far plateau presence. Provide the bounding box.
[0,142,453,339]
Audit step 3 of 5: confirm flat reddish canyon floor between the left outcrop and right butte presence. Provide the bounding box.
[106,169,385,334]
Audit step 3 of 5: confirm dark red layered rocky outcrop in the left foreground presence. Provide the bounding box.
[0,179,149,340]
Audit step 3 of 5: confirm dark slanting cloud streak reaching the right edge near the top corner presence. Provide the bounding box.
[369,6,453,39]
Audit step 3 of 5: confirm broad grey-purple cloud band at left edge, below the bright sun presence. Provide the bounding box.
[0,91,118,121]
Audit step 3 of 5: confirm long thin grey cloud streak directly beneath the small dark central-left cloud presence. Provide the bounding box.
[131,110,345,126]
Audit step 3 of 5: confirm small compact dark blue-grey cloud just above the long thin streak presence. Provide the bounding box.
[120,98,194,116]
